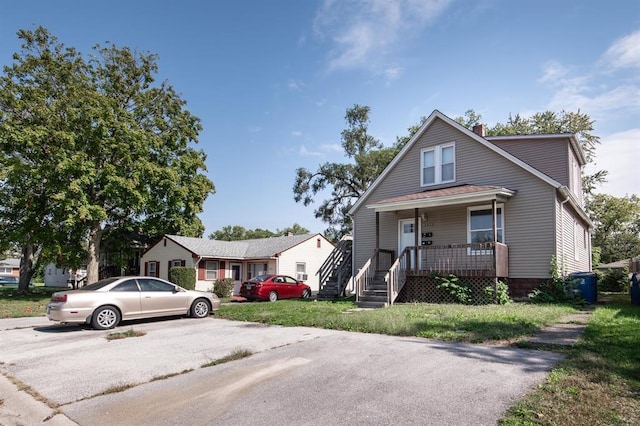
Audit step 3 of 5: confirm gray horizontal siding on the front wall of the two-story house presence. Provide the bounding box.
[354,119,566,278]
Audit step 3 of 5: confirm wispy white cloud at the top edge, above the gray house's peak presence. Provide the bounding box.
[313,0,451,72]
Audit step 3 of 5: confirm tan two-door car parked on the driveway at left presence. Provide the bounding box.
[47,277,220,330]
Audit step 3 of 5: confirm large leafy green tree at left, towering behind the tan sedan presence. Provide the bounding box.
[0,27,214,289]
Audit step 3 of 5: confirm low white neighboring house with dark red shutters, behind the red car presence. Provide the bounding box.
[140,234,334,295]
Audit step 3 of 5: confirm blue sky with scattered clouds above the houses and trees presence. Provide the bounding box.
[0,0,640,236]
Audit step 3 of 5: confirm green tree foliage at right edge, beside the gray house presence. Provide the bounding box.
[586,194,640,263]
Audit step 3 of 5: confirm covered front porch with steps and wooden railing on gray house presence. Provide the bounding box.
[355,185,515,306]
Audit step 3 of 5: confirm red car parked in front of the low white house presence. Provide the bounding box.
[240,275,311,302]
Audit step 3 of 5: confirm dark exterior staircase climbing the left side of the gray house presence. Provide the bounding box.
[316,236,353,300]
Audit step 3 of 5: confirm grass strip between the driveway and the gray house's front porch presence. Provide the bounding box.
[216,299,576,343]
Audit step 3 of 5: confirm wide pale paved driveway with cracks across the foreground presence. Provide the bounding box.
[0,318,561,425]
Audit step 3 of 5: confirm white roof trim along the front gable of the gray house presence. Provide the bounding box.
[349,109,588,216]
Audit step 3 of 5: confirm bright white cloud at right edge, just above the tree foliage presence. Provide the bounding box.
[586,128,640,197]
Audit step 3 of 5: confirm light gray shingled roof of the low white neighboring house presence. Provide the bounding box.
[165,234,330,259]
